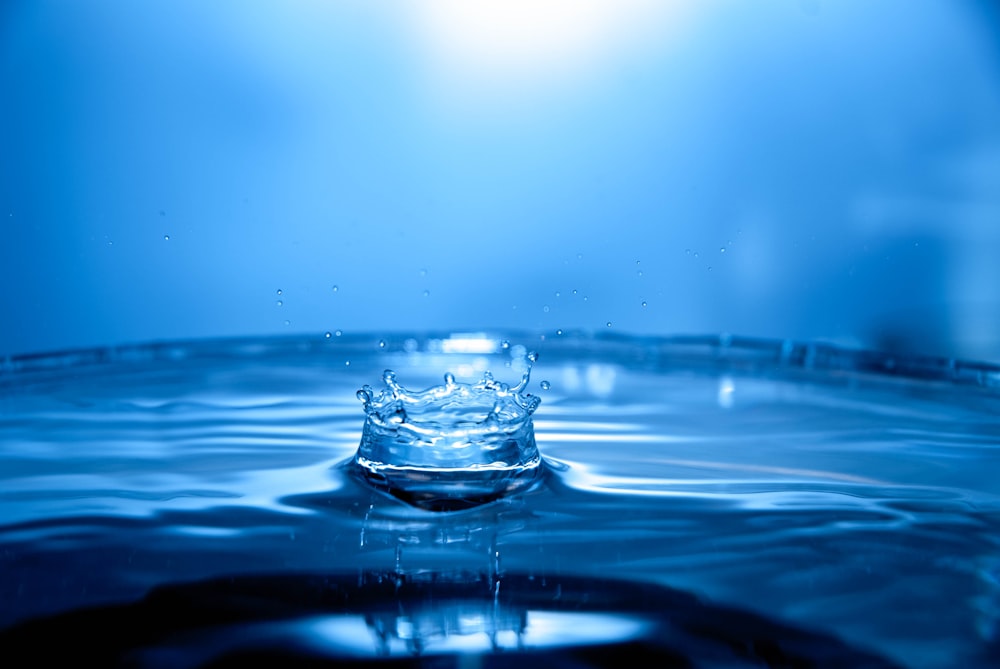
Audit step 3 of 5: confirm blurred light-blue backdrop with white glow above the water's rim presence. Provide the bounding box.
[0,0,1000,361]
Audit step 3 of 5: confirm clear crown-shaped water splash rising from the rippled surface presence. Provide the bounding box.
[354,353,541,510]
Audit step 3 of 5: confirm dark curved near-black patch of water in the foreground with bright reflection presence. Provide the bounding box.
[0,571,894,669]
